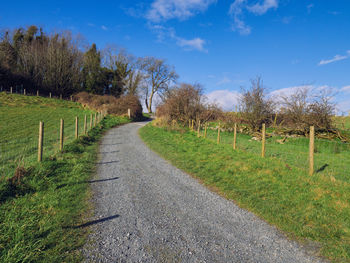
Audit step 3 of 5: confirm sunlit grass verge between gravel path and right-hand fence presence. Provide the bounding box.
[140,125,350,262]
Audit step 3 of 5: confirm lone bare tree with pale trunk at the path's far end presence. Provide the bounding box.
[142,57,178,113]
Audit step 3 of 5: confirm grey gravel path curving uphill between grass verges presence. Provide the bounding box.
[83,123,321,263]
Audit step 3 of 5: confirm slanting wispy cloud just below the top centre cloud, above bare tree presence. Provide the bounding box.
[149,25,208,53]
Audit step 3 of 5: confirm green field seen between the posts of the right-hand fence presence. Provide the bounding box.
[202,127,350,182]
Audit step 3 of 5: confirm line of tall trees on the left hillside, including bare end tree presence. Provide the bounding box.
[0,26,178,112]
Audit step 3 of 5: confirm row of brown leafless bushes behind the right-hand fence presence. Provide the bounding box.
[157,77,335,134]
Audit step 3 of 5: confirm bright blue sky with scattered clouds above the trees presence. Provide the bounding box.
[0,0,350,114]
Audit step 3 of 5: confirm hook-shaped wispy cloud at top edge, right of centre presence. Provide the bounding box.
[229,0,278,35]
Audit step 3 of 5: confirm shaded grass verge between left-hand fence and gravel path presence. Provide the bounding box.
[0,116,129,262]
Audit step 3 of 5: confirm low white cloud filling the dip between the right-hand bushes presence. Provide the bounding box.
[206,90,240,111]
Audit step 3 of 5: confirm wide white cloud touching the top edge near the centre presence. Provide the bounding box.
[146,0,216,22]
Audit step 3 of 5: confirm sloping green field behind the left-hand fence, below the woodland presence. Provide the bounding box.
[0,92,92,178]
